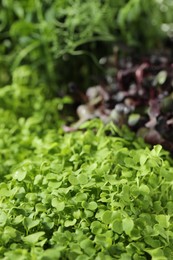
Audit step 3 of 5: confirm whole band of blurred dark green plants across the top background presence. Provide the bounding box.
[0,0,173,95]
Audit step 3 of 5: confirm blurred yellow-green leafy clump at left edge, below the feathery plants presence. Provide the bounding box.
[0,65,71,129]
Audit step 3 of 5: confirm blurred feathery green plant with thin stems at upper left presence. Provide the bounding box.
[1,0,113,92]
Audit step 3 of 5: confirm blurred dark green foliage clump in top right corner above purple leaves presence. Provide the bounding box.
[117,0,173,48]
